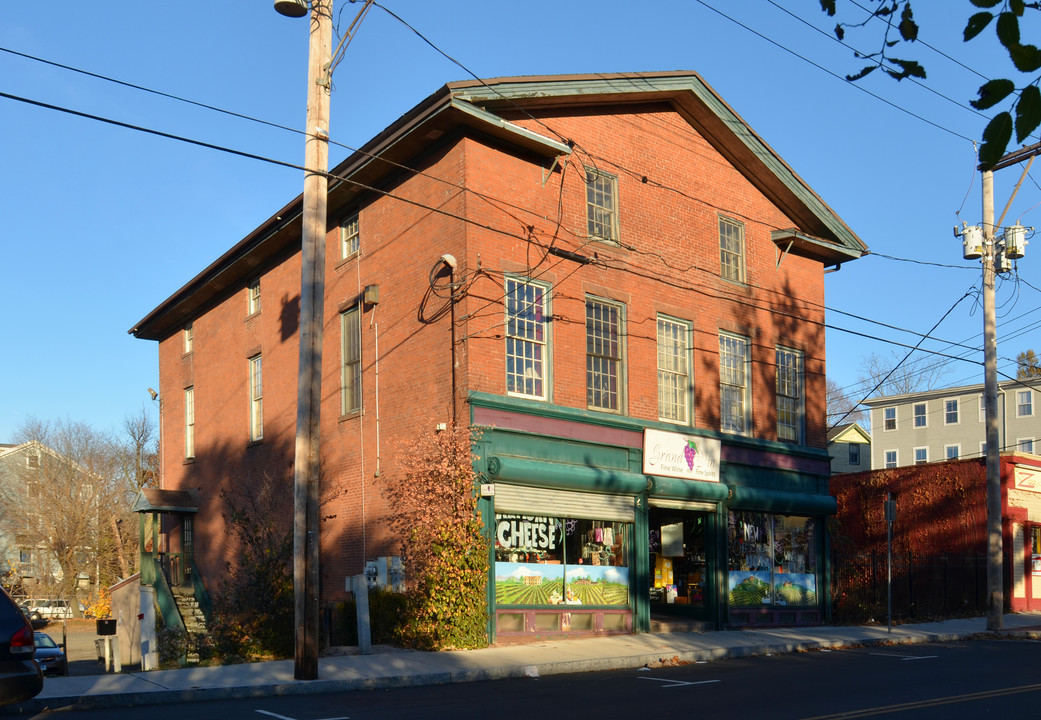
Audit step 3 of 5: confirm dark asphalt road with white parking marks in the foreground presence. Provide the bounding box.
[20,640,1041,720]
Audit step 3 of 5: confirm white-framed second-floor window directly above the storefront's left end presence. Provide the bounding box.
[506,278,549,400]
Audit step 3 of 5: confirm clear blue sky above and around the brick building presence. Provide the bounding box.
[0,0,1041,442]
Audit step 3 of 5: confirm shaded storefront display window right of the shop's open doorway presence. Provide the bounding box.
[728,510,817,607]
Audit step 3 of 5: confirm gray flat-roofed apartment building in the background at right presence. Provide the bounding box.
[864,379,1041,469]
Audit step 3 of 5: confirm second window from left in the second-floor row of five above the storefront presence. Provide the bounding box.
[586,298,623,412]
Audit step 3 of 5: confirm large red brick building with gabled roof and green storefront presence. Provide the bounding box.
[131,72,866,637]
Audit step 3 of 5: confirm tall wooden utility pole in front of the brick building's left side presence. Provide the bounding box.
[275,0,333,680]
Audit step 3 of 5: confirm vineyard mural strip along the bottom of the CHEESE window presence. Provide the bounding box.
[496,562,629,606]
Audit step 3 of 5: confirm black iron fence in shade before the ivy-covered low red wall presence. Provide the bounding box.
[832,552,987,624]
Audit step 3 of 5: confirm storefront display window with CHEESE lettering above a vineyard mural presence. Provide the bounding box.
[496,513,632,606]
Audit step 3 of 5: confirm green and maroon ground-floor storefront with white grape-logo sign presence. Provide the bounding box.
[475,393,835,641]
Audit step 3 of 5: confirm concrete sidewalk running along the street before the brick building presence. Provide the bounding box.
[0,614,1041,715]
